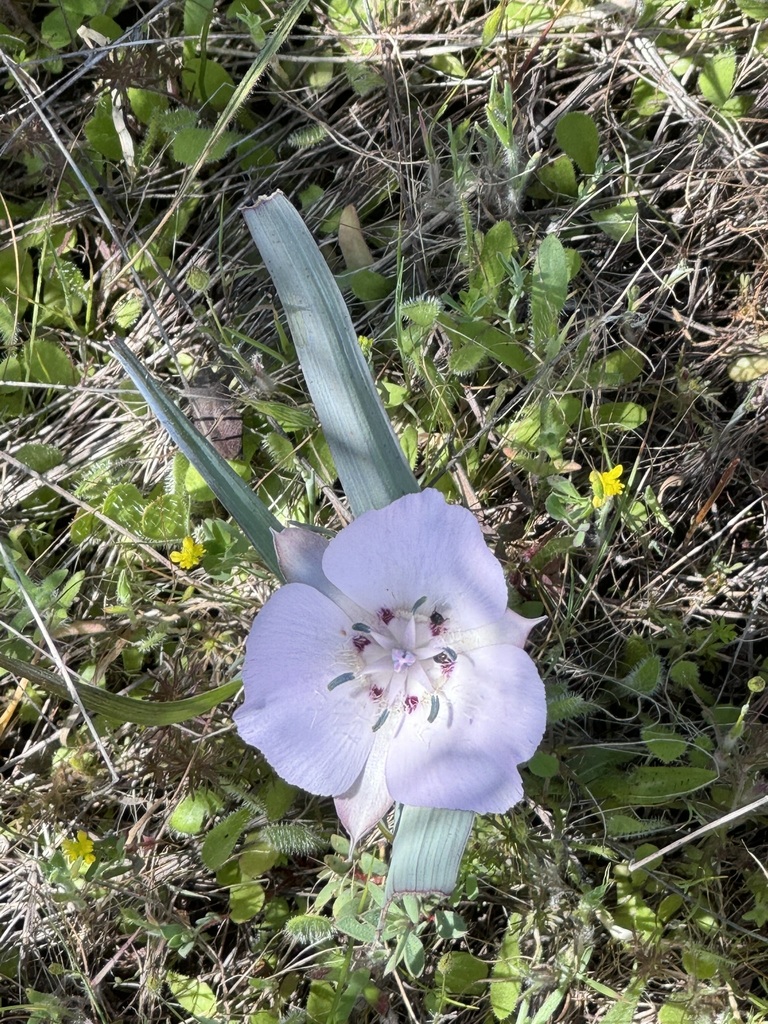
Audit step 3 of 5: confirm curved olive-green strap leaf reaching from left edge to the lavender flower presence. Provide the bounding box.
[0,654,242,725]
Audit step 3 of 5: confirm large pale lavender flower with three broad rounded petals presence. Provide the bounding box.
[234,490,546,842]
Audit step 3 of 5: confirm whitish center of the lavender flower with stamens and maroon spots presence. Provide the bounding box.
[328,597,457,731]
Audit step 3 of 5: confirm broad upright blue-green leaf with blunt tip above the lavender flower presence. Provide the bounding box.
[243,193,419,515]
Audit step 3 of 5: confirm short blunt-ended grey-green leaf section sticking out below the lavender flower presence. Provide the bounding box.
[384,805,475,902]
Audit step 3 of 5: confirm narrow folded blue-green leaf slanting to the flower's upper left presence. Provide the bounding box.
[112,338,283,578]
